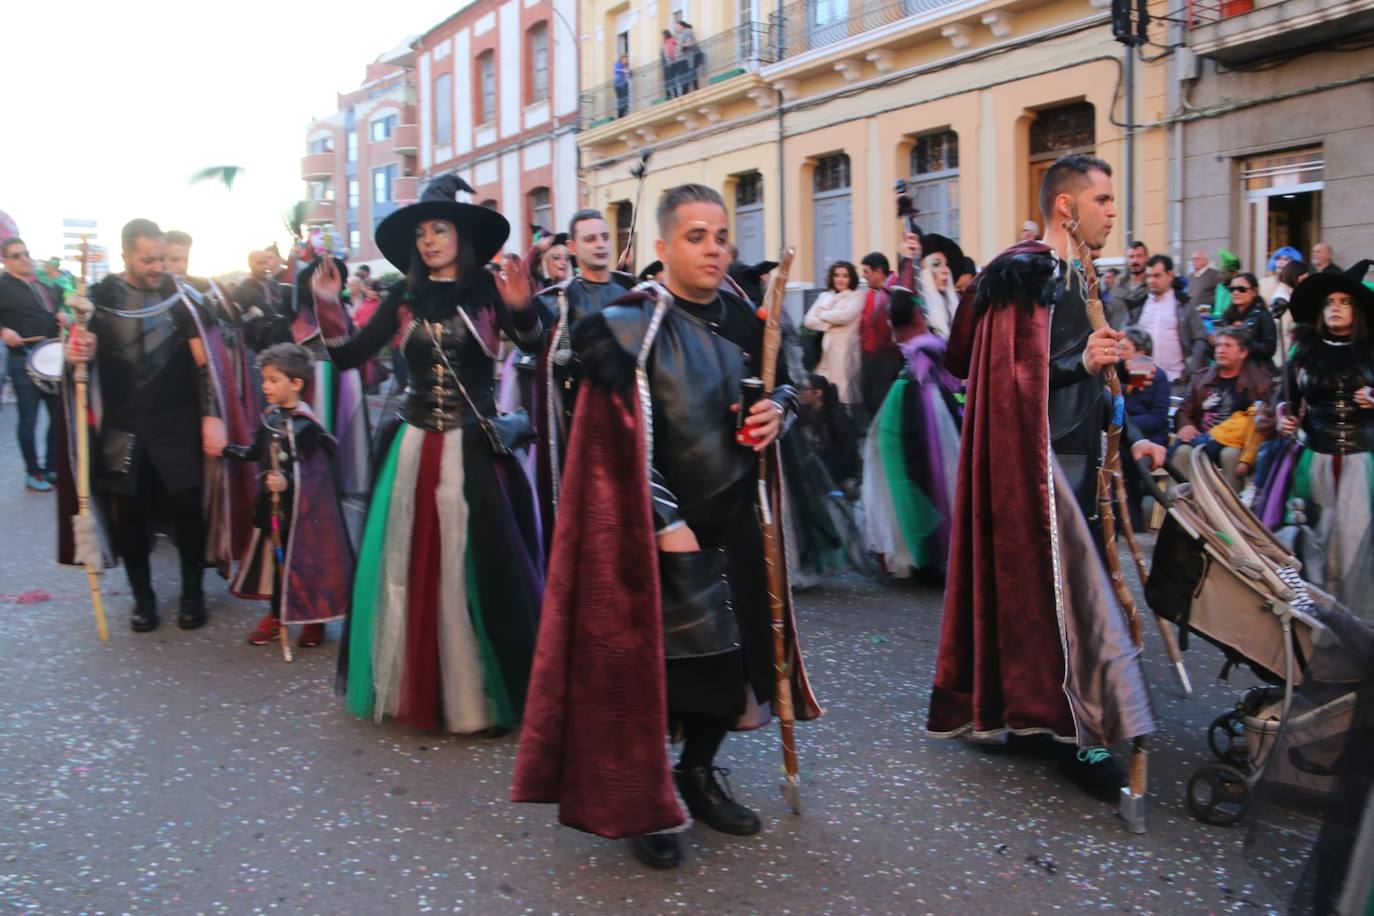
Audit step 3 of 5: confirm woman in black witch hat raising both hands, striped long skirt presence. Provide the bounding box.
[322,174,543,732]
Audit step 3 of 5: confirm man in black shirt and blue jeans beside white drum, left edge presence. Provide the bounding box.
[0,236,62,493]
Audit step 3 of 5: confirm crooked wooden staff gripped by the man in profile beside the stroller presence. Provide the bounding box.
[1063,207,1149,834]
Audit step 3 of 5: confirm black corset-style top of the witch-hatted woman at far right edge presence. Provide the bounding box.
[1297,343,1374,455]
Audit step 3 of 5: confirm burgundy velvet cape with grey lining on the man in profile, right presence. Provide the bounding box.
[927,242,1154,746]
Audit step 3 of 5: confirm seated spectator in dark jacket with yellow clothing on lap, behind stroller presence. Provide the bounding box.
[1169,327,1274,492]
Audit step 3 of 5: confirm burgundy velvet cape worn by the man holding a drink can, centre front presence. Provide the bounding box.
[511,348,823,839]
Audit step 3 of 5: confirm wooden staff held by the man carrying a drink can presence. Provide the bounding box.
[758,249,801,814]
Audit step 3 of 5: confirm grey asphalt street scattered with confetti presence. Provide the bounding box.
[0,405,1282,913]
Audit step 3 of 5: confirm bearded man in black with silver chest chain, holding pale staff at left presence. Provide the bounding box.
[59,220,229,633]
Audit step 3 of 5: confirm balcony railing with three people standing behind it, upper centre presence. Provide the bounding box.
[581,22,778,128]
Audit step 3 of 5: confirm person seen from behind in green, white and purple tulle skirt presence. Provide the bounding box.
[863,282,963,578]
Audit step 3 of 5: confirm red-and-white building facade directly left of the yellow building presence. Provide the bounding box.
[414,0,581,253]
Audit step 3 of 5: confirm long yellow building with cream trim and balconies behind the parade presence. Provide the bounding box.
[578,0,1167,286]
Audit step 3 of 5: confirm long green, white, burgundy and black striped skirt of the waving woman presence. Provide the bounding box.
[339,423,544,733]
